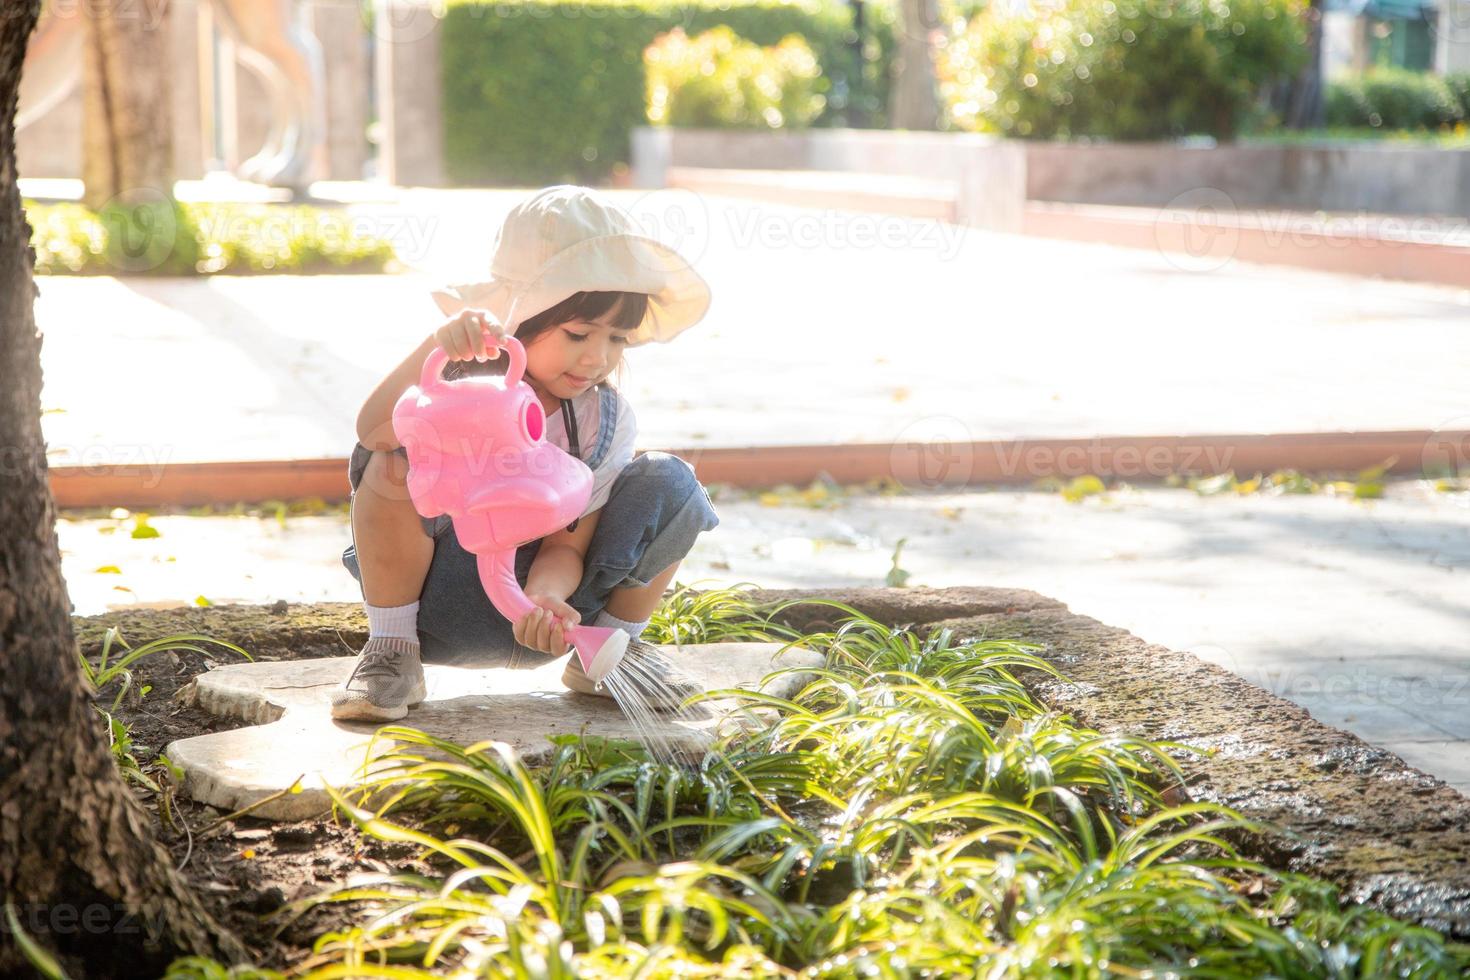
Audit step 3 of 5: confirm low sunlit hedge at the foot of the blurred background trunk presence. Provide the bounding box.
[25,201,397,276]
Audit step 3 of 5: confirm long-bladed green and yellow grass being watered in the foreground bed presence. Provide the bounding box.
[171,589,1470,977]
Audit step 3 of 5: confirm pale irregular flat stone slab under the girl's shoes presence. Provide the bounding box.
[166,644,822,820]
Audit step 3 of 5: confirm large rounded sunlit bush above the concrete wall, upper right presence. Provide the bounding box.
[939,0,1305,140]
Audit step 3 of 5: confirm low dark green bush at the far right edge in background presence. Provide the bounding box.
[1326,68,1470,129]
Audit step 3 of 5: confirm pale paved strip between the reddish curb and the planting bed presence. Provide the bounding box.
[59,482,1470,793]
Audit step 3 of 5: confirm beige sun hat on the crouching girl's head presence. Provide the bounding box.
[432,184,710,347]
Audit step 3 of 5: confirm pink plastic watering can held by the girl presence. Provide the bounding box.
[392,334,628,683]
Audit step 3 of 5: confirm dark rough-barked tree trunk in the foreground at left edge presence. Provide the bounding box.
[0,0,244,977]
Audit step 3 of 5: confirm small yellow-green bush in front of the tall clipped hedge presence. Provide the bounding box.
[644,25,826,129]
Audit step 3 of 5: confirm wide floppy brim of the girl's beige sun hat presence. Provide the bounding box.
[432,234,710,347]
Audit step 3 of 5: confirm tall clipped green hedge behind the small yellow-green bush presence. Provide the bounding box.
[440,0,895,187]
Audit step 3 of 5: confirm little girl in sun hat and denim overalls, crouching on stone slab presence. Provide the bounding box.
[332,184,719,721]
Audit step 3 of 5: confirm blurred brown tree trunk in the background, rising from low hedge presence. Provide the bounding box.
[81,0,173,212]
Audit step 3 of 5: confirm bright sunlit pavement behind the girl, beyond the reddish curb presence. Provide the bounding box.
[28,185,1470,466]
